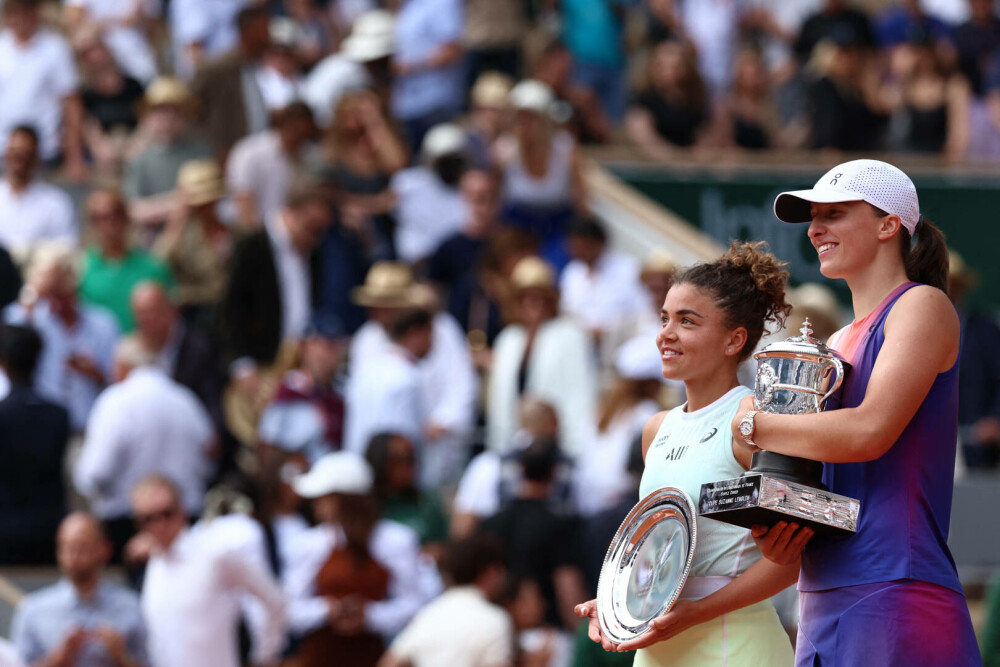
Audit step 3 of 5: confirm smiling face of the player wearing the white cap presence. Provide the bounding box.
[809,201,898,278]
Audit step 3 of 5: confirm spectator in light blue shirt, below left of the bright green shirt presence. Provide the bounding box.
[4,244,119,433]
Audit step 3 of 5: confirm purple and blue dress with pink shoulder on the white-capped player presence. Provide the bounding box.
[795,283,982,667]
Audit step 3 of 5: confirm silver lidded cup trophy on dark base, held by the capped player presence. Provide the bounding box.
[698,319,861,535]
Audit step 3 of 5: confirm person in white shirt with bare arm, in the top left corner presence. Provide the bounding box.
[0,0,86,179]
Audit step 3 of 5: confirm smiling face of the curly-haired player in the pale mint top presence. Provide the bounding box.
[656,283,746,382]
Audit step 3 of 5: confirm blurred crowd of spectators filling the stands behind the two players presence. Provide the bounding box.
[0,0,1000,667]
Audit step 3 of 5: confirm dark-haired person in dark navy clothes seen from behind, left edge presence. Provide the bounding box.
[0,325,70,565]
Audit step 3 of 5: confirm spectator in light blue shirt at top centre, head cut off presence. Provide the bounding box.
[392,0,465,153]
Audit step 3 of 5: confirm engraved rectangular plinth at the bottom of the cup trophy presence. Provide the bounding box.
[698,472,861,535]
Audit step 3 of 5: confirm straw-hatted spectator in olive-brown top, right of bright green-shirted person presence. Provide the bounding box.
[153,158,234,320]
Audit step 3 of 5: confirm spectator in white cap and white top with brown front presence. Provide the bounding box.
[286,451,441,665]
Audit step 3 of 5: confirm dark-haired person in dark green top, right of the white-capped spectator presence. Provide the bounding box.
[366,433,448,557]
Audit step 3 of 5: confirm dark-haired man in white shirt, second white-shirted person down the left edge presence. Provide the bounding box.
[0,125,79,255]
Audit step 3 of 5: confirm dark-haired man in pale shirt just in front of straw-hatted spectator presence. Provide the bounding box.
[344,309,433,454]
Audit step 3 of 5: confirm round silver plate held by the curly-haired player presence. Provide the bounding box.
[597,486,698,644]
